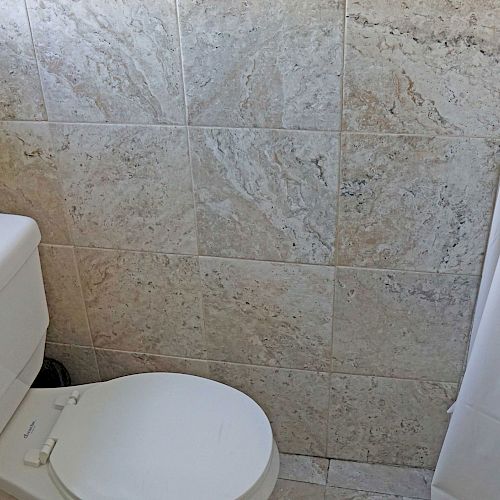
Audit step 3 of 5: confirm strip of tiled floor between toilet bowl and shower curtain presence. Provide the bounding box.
[270,454,433,500]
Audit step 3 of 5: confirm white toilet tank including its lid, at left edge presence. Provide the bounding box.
[0,214,49,432]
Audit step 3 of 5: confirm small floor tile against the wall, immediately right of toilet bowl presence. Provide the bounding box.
[279,453,328,484]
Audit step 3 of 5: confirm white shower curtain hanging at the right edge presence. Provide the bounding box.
[432,188,500,500]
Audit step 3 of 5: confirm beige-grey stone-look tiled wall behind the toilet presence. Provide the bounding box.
[0,0,500,468]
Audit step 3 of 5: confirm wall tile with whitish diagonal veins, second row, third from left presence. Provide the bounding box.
[190,129,339,264]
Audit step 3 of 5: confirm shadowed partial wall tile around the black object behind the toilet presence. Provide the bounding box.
[45,342,100,385]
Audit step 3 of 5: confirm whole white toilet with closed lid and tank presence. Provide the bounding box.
[0,214,279,500]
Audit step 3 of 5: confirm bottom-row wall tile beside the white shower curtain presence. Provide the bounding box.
[328,374,456,468]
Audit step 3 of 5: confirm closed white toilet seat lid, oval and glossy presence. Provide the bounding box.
[49,373,273,500]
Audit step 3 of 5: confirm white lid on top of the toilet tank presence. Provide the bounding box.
[0,214,41,290]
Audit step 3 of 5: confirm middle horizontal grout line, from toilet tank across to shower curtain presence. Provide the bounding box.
[45,242,480,278]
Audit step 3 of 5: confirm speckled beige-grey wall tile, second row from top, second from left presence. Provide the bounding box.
[51,124,196,254]
